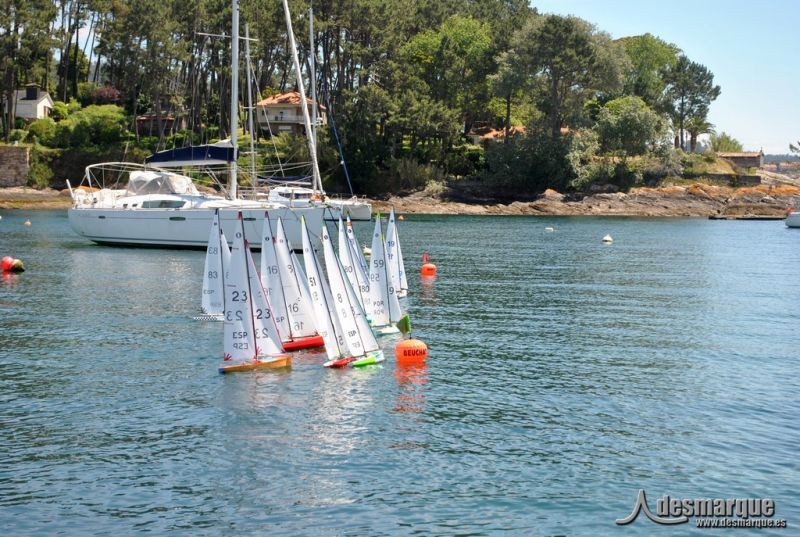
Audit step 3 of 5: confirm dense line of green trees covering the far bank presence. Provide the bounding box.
[0,0,735,193]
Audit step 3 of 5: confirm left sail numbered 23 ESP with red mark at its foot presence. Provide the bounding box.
[223,216,257,365]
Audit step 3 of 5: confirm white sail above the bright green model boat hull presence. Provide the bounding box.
[322,223,378,357]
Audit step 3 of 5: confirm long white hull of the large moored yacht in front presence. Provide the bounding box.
[68,207,323,249]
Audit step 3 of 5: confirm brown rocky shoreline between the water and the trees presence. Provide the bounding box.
[0,183,800,218]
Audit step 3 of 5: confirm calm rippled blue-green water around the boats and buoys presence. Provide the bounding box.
[0,211,800,536]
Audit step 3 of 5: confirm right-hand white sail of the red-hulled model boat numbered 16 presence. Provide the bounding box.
[275,218,317,338]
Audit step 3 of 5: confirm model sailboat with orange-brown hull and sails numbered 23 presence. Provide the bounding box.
[219,213,291,373]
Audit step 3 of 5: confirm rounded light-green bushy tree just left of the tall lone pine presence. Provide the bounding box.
[595,96,663,156]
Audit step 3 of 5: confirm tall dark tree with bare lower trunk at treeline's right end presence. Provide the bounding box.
[663,55,721,150]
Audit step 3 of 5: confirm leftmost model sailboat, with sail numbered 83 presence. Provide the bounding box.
[195,211,231,321]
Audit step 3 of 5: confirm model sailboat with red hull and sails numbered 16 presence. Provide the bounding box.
[261,211,325,351]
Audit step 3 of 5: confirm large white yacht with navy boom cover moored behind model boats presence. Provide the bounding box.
[67,0,330,248]
